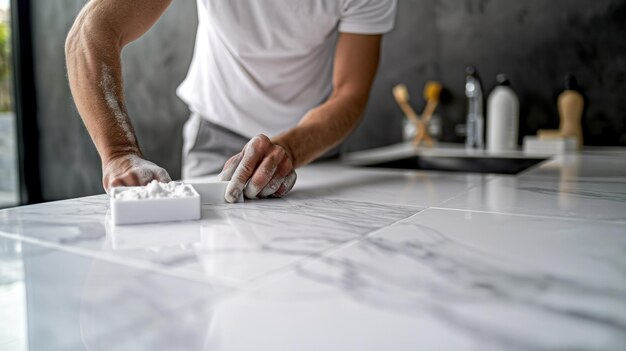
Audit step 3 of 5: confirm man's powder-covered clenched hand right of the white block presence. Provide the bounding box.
[219,134,297,202]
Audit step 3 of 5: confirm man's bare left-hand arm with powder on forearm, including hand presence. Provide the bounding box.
[65,0,172,190]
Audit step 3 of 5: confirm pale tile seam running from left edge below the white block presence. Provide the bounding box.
[0,231,238,289]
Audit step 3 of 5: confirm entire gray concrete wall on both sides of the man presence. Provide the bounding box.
[32,0,626,200]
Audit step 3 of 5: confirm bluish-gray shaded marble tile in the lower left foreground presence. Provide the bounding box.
[0,238,225,351]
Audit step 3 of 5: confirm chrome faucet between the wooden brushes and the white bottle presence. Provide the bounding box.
[465,66,485,149]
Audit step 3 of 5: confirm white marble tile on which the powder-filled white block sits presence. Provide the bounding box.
[0,194,420,285]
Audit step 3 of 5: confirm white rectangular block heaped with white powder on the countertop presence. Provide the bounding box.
[110,180,200,225]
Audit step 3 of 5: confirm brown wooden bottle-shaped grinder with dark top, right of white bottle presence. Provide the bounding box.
[537,73,585,149]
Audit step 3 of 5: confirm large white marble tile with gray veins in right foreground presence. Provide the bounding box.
[210,210,626,350]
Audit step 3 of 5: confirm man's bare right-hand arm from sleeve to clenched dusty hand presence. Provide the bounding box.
[221,33,382,201]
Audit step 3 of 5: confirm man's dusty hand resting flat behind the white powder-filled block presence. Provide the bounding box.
[102,154,172,192]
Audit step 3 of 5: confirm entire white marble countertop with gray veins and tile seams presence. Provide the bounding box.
[0,150,626,351]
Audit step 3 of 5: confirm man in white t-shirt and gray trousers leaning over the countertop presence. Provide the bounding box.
[66,0,396,201]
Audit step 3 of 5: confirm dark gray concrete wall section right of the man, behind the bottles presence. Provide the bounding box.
[347,0,626,150]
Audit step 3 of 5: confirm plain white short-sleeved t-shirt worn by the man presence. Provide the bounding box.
[177,0,397,137]
